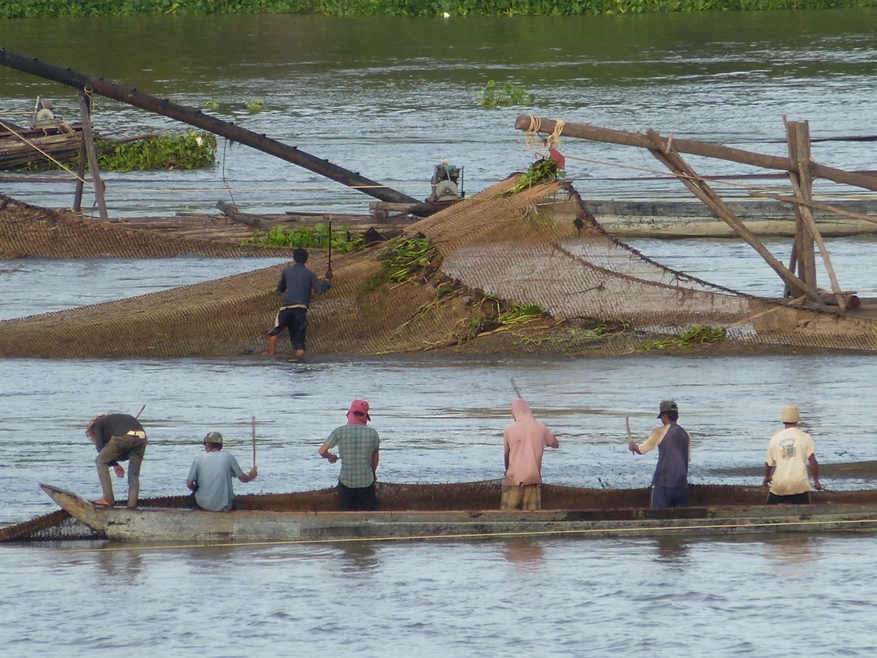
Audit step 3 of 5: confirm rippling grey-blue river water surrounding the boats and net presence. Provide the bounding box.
[0,11,877,656]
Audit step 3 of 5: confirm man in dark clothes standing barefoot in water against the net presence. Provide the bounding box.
[266,247,332,359]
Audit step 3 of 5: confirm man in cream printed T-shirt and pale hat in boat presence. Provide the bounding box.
[763,405,822,505]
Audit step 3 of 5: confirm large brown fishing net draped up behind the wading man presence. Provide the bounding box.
[0,176,877,357]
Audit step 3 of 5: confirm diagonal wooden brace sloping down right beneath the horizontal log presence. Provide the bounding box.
[647,128,820,302]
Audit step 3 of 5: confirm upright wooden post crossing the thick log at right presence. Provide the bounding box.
[783,118,846,311]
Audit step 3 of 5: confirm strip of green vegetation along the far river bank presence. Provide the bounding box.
[0,0,877,18]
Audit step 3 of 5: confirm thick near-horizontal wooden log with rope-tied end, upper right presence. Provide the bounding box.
[515,114,877,191]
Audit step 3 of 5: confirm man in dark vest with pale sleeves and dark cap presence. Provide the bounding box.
[627,400,691,507]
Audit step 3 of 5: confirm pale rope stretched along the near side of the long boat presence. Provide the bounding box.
[24,510,877,553]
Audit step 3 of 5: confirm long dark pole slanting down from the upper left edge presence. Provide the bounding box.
[0,49,417,203]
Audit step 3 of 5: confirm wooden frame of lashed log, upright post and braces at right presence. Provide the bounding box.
[515,114,877,311]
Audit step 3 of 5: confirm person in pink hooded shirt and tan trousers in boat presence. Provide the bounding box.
[500,398,560,510]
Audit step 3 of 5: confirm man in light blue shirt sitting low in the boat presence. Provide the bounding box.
[186,432,259,512]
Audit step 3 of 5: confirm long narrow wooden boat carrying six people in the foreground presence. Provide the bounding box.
[41,481,877,543]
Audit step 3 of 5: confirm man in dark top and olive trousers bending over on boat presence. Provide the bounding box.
[85,414,147,507]
